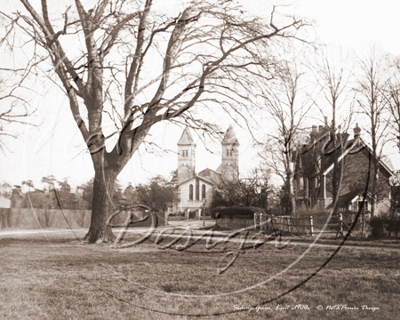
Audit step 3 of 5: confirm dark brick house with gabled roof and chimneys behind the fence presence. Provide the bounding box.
[293,124,394,213]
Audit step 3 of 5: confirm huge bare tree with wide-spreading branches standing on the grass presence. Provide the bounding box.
[3,0,304,243]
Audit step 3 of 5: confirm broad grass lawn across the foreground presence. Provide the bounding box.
[0,229,400,320]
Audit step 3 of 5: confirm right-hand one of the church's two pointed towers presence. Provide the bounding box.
[221,125,240,181]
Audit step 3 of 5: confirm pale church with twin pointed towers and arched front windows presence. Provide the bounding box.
[173,125,240,212]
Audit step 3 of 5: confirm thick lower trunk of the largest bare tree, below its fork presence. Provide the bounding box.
[84,170,117,243]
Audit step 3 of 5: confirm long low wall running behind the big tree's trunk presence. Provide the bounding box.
[0,208,166,229]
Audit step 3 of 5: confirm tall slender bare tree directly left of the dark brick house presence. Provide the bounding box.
[260,61,312,215]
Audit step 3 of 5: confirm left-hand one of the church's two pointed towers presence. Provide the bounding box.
[178,127,196,184]
